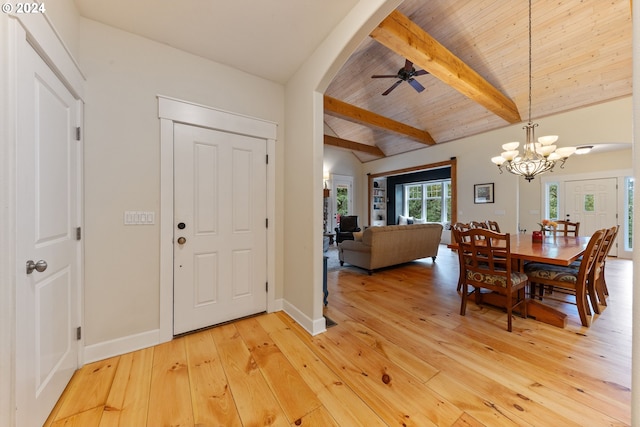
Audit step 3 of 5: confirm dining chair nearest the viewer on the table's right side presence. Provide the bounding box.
[524,229,607,326]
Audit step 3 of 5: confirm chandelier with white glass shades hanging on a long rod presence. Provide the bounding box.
[491,0,576,182]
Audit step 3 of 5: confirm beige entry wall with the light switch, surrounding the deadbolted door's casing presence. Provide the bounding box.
[79,18,285,345]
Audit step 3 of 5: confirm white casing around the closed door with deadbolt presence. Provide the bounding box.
[158,95,282,343]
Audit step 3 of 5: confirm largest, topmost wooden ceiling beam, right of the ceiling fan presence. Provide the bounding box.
[371,11,522,123]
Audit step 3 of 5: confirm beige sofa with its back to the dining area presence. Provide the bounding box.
[338,223,442,274]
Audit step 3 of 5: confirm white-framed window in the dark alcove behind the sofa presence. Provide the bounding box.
[404,180,451,223]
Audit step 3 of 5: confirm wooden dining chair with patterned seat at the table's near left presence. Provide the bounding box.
[458,228,529,332]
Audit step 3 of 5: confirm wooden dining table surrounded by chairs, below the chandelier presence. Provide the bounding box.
[448,233,591,328]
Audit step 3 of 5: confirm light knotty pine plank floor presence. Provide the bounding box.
[46,246,632,427]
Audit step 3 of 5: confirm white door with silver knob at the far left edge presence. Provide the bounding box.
[16,47,81,426]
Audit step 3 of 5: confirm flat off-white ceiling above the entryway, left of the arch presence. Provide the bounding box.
[75,0,358,83]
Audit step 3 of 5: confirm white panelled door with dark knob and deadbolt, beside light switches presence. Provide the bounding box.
[174,124,267,334]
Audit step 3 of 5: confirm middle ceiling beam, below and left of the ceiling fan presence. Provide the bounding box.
[324,95,436,145]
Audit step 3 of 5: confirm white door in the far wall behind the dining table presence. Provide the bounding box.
[564,178,618,256]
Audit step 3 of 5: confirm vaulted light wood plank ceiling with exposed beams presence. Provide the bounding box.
[324,0,632,162]
